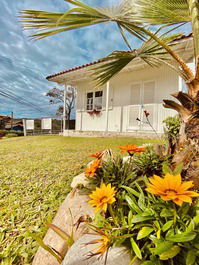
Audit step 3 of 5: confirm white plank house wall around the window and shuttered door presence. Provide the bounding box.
[76,66,179,132]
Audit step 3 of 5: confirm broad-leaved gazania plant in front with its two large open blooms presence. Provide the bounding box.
[84,158,199,265]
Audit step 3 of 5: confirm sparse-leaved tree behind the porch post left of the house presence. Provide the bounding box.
[46,87,76,129]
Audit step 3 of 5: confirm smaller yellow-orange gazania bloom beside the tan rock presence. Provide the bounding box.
[88,183,116,212]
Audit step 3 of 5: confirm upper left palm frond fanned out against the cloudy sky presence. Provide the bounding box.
[20,0,146,40]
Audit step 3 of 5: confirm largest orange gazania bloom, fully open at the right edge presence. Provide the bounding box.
[146,173,199,206]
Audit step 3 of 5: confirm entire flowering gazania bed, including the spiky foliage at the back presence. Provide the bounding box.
[80,147,199,265]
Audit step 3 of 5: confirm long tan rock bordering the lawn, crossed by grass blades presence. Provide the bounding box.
[32,190,94,265]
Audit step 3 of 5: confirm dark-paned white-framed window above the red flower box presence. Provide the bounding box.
[86,90,103,110]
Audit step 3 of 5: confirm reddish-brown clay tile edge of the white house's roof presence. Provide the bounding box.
[46,33,192,80]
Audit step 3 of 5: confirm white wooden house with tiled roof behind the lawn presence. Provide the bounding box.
[47,35,193,135]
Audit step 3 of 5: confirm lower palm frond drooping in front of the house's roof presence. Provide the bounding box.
[92,34,187,86]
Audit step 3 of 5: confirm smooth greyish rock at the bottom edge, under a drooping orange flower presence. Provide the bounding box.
[62,234,139,265]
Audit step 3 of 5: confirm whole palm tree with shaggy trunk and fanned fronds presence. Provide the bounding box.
[21,0,199,144]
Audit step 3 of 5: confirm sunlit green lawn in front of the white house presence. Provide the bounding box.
[0,136,156,265]
